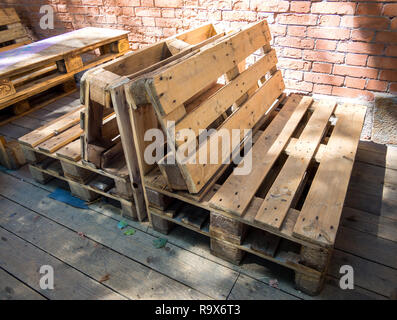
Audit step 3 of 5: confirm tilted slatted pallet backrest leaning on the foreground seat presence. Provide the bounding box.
[127,21,284,193]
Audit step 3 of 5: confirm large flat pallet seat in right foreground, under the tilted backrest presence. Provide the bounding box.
[144,95,366,294]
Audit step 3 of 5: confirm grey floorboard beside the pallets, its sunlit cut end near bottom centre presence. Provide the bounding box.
[0,172,238,299]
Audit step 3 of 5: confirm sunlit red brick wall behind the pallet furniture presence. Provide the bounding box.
[3,0,397,100]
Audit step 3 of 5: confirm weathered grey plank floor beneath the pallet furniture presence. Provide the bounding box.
[0,94,397,299]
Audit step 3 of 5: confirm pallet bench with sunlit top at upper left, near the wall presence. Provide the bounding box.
[0,28,129,126]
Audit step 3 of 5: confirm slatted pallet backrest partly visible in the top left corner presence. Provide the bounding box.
[0,8,32,53]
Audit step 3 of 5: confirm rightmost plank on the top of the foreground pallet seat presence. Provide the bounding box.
[294,105,366,246]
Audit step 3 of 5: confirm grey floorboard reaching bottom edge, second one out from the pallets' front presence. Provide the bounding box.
[0,196,208,299]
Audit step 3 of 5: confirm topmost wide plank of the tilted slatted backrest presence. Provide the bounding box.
[147,20,270,115]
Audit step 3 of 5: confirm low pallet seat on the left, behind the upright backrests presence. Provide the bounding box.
[19,107,137,220]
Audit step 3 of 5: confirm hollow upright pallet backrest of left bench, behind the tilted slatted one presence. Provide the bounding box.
[81,24,224,172]
